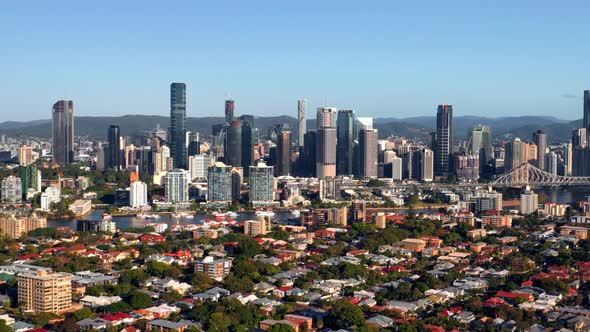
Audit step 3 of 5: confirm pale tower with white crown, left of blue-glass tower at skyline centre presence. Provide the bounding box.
[316,107,338,179]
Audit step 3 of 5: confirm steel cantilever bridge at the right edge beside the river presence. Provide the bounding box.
[488,163,590,187]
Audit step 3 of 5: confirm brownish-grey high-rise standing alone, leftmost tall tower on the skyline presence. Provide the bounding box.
[51,100,74,165]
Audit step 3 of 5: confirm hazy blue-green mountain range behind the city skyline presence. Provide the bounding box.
[0,115,582,142]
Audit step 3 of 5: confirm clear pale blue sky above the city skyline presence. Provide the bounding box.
[0,0,590,121]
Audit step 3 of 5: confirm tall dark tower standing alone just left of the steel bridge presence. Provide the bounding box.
[434,105,453,176]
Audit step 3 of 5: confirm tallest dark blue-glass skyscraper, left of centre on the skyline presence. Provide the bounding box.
[170,83,186,168]
